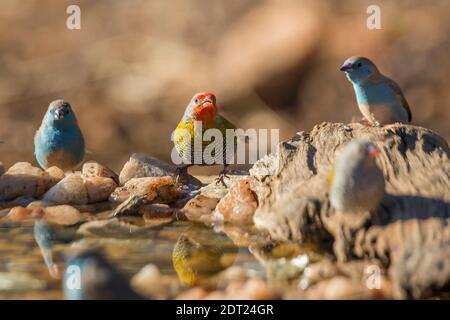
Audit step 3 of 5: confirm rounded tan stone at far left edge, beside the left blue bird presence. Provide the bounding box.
[0,162,46,200]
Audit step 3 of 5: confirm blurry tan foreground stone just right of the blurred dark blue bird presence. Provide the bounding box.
[131,264,179,299]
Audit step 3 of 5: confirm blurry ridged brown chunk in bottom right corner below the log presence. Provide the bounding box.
[354,218,450,299]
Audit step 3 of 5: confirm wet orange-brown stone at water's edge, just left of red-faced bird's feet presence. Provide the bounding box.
[109,176,177,203]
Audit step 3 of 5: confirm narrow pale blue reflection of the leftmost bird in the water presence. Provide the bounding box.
[33,220,61,279]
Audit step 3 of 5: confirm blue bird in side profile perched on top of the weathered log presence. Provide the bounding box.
[340,57,412,127]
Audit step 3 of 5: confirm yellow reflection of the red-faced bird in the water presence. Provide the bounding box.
[172,226,238,286]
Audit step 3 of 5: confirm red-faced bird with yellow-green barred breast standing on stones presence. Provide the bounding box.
[173,92,236,184]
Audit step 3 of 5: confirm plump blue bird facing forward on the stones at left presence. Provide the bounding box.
[34,100,85,171]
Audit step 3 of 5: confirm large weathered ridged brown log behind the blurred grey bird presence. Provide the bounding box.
[250,123,450,297]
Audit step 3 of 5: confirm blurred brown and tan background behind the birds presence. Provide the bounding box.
[0,0,450,170]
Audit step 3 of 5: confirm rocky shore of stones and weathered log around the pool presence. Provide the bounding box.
[0,123,450,299]
